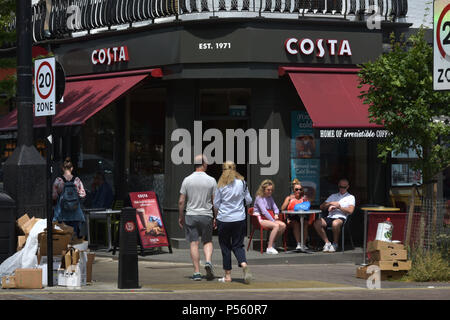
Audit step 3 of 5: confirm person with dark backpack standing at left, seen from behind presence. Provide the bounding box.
[52,157,86,238]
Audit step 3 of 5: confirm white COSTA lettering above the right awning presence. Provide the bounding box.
[284,38,352,58]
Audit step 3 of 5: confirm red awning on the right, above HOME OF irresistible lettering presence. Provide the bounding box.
[279,67,382,128]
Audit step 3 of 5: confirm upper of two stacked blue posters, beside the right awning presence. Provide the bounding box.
[291,111,320,159]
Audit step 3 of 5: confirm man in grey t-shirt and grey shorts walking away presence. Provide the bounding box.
[178,155,217,281]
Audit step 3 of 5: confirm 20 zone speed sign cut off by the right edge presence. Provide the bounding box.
[433,0,450,90]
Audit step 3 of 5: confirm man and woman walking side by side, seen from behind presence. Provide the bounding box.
[178,155,252,284]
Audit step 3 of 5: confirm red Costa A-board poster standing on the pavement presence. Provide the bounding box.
[130,191,169,249]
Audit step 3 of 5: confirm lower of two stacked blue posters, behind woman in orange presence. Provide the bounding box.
[291,159,320,204]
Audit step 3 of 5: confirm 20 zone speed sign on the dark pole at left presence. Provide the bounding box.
[34,58,56,117]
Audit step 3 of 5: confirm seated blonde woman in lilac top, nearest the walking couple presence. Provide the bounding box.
[253,180,286,254]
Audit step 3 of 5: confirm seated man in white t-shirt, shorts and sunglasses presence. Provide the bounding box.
[314,179,355,252]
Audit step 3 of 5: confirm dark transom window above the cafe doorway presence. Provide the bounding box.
[200,88,251,117]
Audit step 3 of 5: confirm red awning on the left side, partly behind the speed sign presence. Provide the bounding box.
[0,69,161,131]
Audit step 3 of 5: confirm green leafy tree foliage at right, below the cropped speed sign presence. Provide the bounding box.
[359,29,450,190]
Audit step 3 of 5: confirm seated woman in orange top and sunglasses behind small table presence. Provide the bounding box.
[281,179,309,250]
